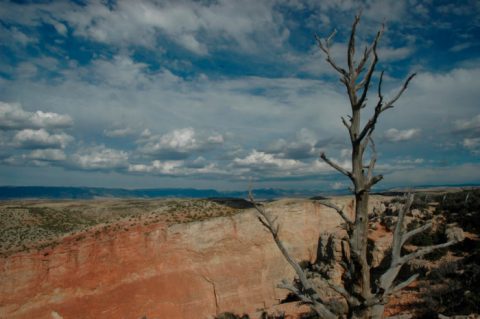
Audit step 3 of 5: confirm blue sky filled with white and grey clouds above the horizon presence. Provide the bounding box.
[0,0,480,190]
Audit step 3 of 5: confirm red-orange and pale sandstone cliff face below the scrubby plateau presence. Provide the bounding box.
[0,200,347,319]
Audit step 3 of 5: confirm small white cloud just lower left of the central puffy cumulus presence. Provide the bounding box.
[71,145,128,170]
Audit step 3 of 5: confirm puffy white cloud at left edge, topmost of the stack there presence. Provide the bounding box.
[0,102,73,130]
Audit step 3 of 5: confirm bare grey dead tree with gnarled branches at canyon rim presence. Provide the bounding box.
[250,15,463,319]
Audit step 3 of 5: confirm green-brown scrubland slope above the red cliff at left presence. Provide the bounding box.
[0,199,242,256]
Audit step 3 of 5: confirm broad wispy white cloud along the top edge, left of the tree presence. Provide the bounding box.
[58,1,288,55]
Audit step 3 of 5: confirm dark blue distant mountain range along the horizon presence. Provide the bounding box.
[0,185,478,200]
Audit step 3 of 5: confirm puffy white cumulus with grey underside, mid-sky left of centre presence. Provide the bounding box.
[138,127,224,159]
